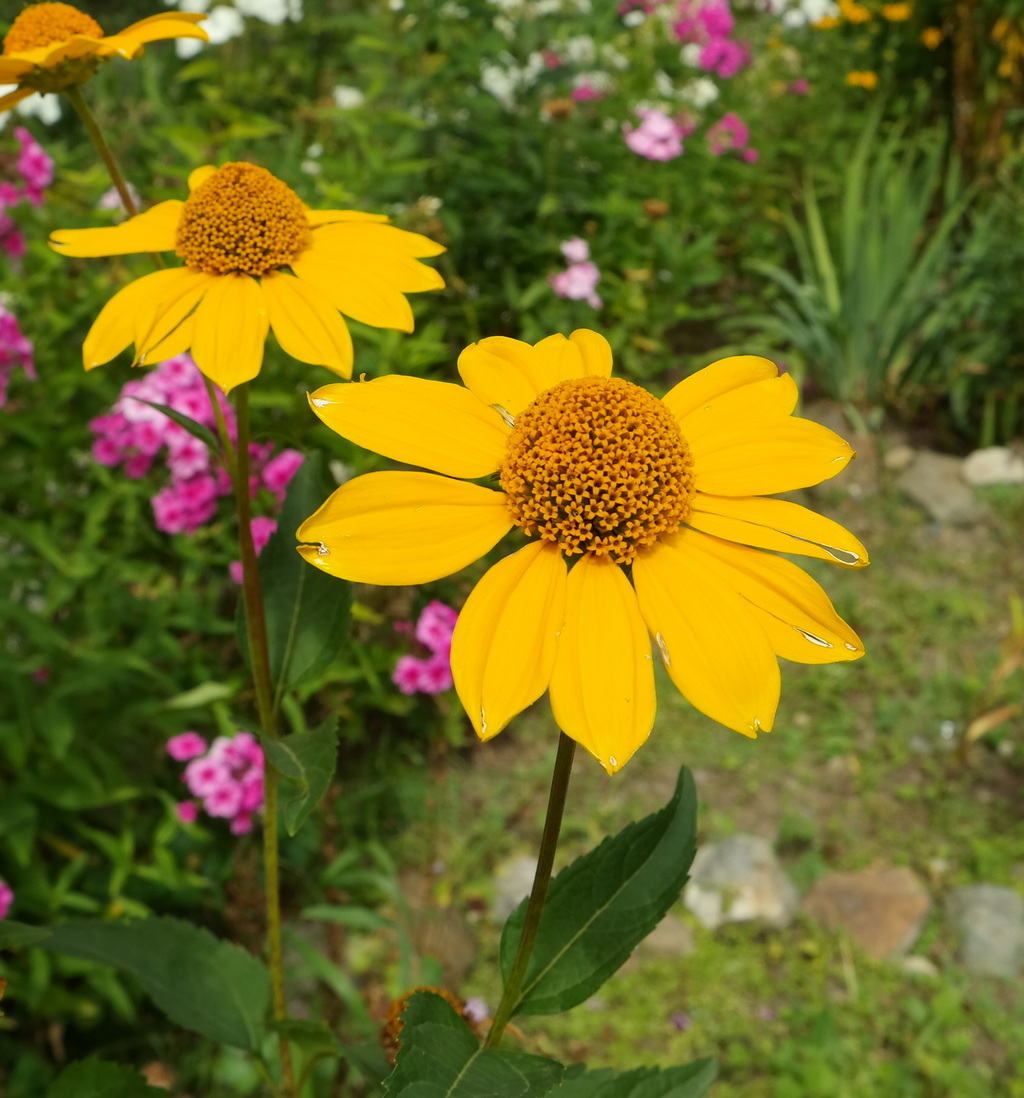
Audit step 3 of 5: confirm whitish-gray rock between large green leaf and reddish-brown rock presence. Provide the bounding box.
[683,834,799,930]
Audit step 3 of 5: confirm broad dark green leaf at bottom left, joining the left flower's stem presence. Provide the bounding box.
[42,917,270,1052]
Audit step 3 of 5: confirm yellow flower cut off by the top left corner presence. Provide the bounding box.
[0,3,206,111]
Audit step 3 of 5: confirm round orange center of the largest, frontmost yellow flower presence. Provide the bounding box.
[500,378,694,564]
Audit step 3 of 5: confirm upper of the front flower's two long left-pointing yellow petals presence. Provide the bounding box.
[310,374,508,480]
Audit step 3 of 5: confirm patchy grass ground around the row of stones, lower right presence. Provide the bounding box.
[384,480,1024,1098]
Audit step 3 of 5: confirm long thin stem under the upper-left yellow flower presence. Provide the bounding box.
[232,385,295,1098]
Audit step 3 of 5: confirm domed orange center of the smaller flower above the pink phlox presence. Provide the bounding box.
[177,164,312,275]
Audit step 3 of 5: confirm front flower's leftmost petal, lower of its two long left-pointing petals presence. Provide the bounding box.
[296,472,513,584]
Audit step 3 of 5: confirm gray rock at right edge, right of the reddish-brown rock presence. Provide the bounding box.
[946,884,1024,978]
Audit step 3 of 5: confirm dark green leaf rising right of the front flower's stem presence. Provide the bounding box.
[502,769,697,1015]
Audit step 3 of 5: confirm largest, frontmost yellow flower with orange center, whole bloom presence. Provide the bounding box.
[299,329,868,773]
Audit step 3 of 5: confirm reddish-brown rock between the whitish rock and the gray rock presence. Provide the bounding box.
[803,866,932,960]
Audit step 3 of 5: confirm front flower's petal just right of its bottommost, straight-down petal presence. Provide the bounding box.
[633,538,781,737]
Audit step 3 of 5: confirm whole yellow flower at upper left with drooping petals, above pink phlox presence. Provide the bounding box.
[50,164,445,392]
